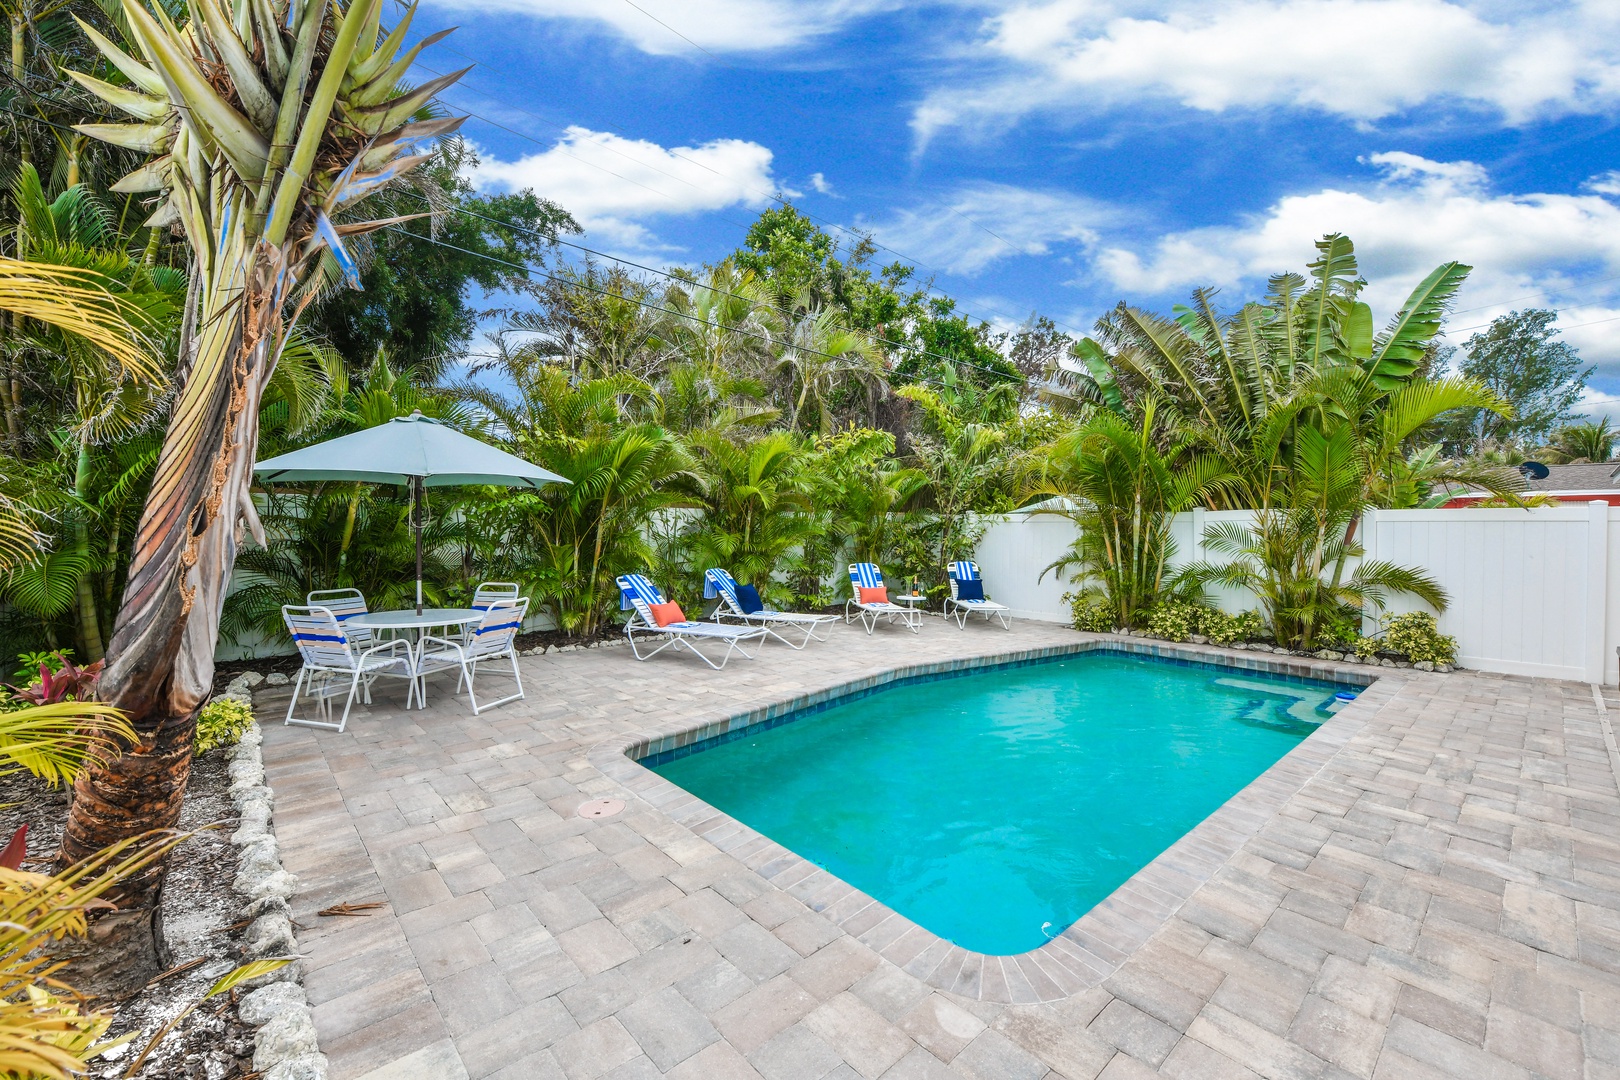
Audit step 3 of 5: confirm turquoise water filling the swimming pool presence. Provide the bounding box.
[643,653,1345,955]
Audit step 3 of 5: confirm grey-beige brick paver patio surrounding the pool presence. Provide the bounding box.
[259,620,1620,1080]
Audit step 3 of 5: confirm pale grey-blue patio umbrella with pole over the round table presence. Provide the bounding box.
[253,411,570,615]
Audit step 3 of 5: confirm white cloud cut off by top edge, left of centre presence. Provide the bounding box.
[424,0,894,58]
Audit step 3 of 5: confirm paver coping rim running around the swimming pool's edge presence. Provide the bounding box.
[588,635,1406,1004]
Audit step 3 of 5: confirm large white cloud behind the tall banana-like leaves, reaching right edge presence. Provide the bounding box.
[1092,152,1620,376]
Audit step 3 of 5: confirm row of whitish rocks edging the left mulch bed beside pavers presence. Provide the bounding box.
[215,672,327,1080]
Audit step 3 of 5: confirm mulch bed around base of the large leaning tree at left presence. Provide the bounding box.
[0,750,253,1080]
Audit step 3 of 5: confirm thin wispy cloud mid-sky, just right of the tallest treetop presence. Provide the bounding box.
[860,183,1116,275]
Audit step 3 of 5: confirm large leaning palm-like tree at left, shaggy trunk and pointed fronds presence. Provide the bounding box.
[62,0,465,994]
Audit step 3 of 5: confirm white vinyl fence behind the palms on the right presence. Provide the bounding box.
[977,504,1620,683]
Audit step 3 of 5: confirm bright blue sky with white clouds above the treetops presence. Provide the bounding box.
[401,0,1620,411]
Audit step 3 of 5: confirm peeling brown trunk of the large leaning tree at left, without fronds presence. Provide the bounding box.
[60,257,279,996]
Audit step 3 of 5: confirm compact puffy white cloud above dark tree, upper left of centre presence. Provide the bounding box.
[471,126,776,249]
